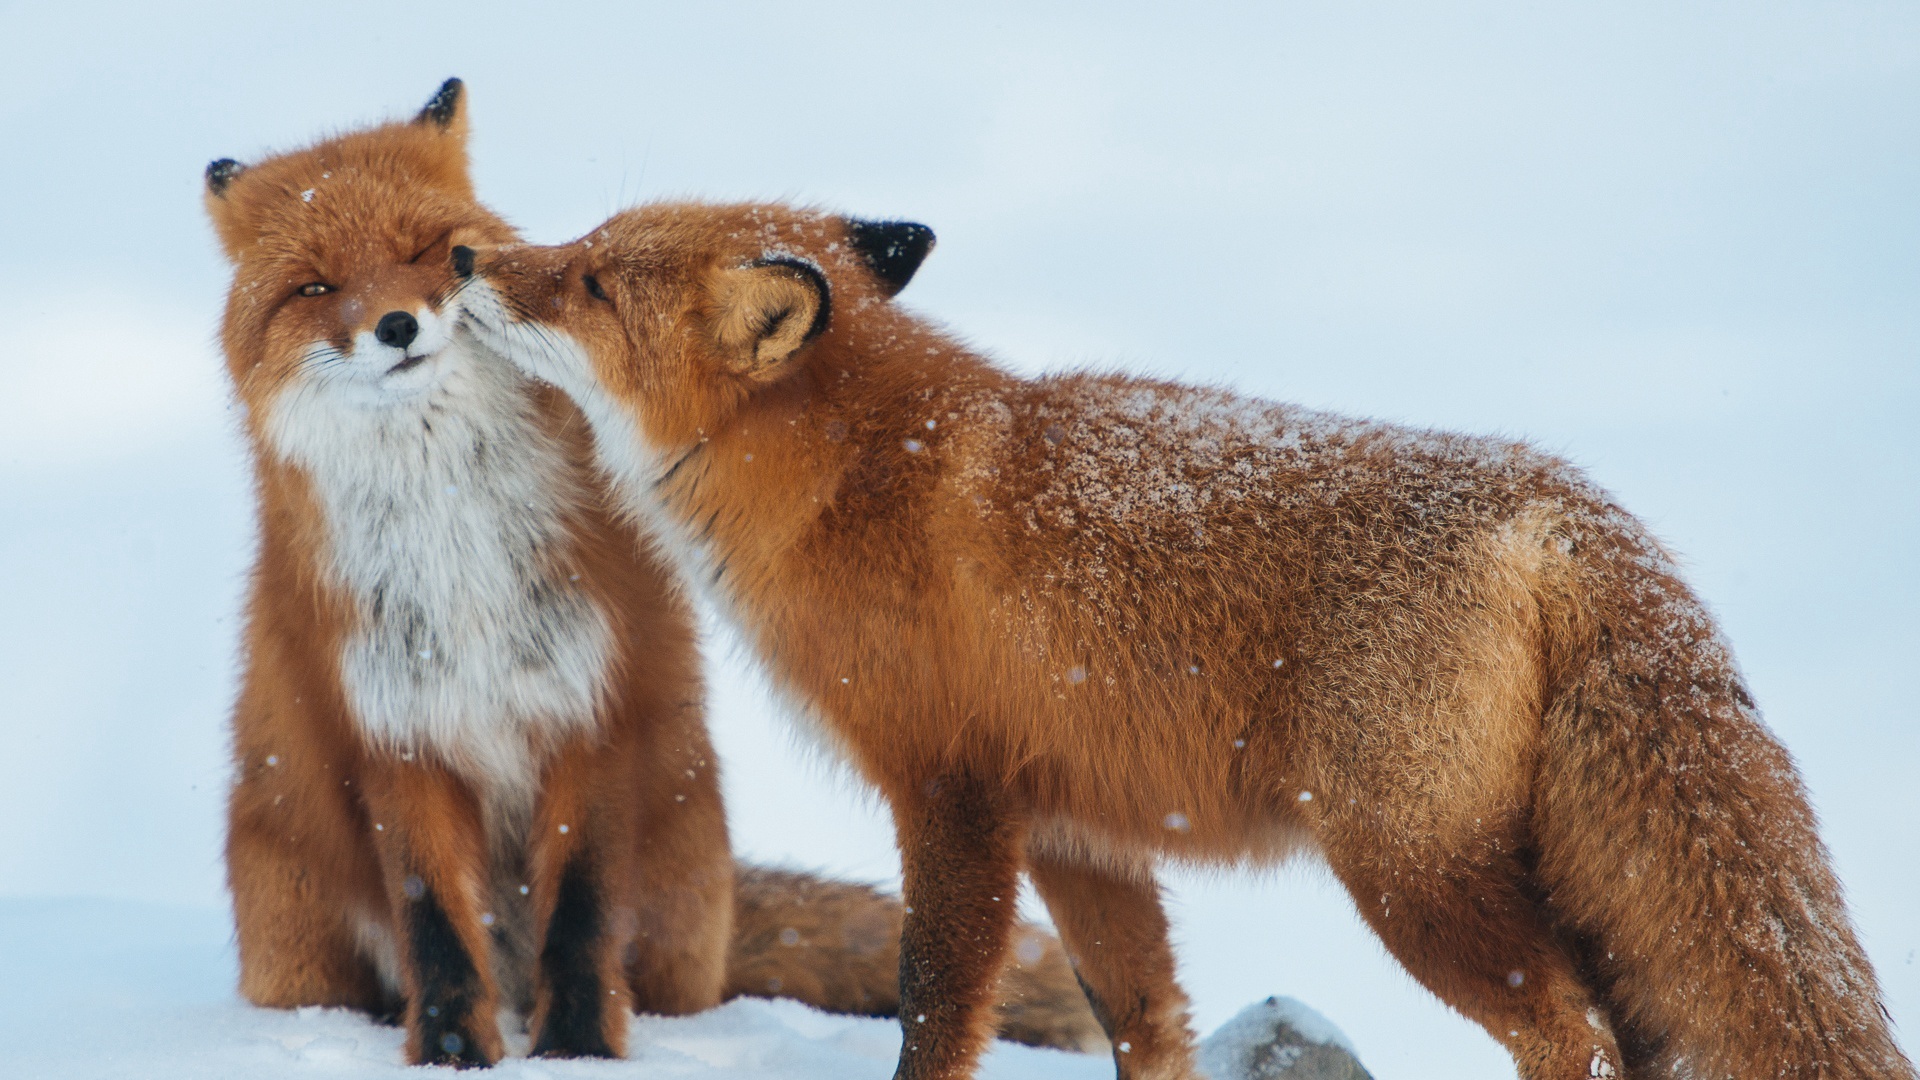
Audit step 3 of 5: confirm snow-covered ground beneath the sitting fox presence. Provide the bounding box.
[0,899,1112,1080]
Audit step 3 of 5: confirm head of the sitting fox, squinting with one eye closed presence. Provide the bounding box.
[205,79,515,404]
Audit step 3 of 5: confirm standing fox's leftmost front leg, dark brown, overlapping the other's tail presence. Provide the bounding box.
[893,776,1025,1080]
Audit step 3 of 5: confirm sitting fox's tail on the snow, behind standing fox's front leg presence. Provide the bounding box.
[726,863,1108,1053]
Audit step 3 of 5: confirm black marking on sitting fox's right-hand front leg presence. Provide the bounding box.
[534,859,616,1057]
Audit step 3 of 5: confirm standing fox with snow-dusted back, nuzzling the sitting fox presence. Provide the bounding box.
[449,202,1914,1080]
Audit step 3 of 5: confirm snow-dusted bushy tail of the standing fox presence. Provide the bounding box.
[1536,530,1914,1080]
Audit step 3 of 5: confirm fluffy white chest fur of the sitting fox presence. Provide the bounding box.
[267,338,612,799]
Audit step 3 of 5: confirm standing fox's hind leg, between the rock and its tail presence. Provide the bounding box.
[1323,818,1624,1080]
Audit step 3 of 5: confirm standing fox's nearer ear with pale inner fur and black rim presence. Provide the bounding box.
[712,256,833,382]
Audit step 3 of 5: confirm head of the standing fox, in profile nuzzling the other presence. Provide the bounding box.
[453,204,933,455]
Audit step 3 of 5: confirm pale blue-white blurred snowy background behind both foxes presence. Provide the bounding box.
[0,0,1920,1080]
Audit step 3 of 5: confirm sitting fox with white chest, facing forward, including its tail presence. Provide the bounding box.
[205,79,1106,1067]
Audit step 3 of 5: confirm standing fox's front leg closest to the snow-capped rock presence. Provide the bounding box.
[1027,851,1194,1080]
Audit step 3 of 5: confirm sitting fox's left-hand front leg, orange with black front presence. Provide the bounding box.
[367,761,505,1067]
